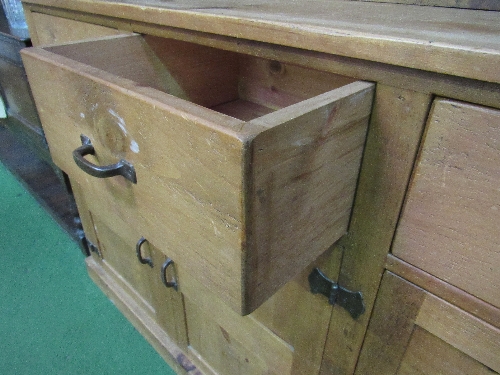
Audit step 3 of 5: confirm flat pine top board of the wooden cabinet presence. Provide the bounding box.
[20,0,500,83]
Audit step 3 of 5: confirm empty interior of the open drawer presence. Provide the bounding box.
[46,35,355,121]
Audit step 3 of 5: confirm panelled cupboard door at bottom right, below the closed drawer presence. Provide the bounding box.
[355,272,500,375]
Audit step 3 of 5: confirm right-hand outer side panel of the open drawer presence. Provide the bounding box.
[245,82,373,312]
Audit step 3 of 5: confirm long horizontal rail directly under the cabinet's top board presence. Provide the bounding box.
[27,5,500,108]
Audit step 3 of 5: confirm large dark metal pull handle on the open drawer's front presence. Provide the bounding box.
[73,134,137,184]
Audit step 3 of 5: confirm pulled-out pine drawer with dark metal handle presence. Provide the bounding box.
[22,35,374,314]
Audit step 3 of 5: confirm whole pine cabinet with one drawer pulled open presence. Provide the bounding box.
[17,0,500,375]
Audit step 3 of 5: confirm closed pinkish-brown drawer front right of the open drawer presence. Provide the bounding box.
[393,99,500,307]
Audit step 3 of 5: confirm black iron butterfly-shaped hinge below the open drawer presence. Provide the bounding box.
[309,268,365,319]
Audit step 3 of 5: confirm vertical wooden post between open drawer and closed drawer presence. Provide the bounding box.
[321,85,432,374]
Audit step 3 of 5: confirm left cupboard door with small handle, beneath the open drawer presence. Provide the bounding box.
[71,181,187,348]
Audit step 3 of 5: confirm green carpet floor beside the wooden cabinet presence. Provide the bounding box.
[0,164,174,375]
